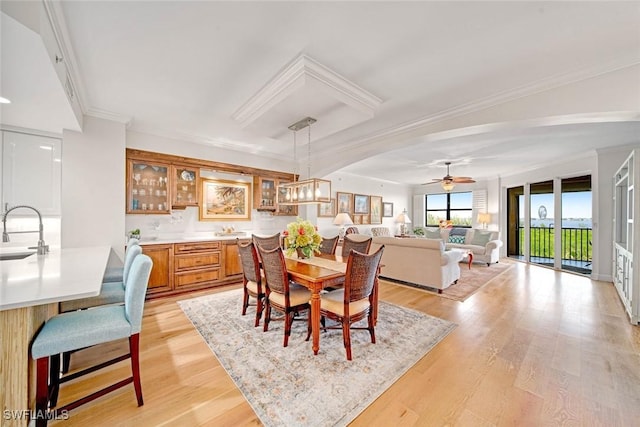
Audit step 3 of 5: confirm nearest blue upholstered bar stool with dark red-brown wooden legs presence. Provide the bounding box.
[31,255,153,427]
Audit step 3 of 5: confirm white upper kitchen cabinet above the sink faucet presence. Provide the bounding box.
[0,131,62,216]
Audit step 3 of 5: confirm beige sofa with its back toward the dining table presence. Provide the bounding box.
[370,237,462,292]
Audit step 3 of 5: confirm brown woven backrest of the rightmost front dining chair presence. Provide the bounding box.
[344,245,384,305]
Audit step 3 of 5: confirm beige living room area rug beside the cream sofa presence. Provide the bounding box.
[381,261,512,301]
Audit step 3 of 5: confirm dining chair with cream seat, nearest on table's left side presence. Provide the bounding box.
[258,246,311,347]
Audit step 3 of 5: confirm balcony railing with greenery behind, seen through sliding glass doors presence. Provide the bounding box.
[517,227,592,271]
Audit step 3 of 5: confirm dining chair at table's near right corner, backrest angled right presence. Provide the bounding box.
[320,245,384,360]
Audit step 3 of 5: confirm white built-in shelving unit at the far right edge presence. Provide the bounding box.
[613,150,640,324]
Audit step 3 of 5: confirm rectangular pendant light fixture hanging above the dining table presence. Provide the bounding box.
[278,117,331,205]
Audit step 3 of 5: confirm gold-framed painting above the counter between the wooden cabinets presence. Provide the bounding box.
[200,178,251,221]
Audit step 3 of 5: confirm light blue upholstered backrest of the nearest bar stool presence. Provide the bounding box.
[124,254,153,334]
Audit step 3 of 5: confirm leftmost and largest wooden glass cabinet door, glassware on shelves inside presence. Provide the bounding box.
[127,159,170,214]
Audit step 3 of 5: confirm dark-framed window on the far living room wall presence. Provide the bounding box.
[425,191,473,227]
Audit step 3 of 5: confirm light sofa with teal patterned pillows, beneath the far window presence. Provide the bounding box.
[424,227,502,266]
